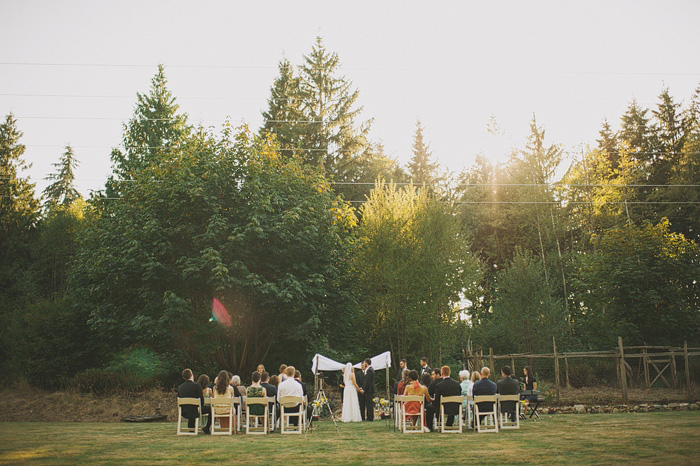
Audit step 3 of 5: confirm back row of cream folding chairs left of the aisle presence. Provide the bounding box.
[177,396,308,435]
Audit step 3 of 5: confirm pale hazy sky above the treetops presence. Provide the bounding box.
[0,0,700,195]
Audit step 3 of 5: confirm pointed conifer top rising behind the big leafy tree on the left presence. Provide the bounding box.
[112,65,191,179]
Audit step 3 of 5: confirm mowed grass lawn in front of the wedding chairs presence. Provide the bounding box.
[0,411,700,464]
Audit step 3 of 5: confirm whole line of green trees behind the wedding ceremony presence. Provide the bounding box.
[0,39,700,390]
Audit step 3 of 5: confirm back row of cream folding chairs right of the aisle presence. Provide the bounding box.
[394,395,520,433]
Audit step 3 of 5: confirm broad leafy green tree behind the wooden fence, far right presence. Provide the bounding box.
[577,220,700,347]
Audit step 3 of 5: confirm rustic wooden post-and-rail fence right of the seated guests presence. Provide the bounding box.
[464,337,700,403]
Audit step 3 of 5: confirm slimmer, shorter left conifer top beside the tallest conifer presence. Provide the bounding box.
[260,58,304,156]
